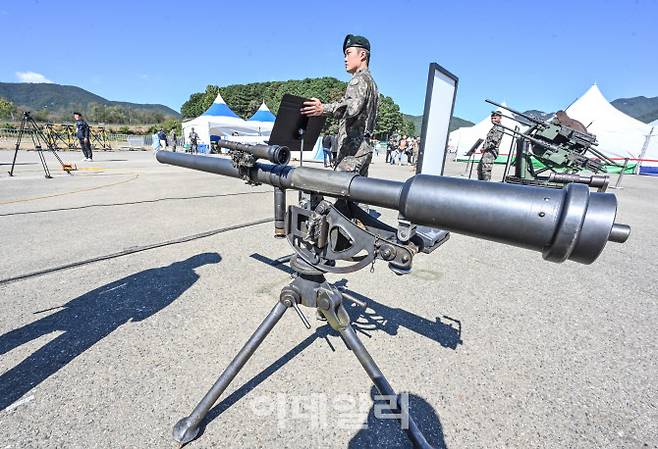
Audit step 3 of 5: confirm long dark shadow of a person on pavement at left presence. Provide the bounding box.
[0,253,221,410]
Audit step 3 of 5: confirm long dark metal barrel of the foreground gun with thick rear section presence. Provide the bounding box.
[156,151,626,264]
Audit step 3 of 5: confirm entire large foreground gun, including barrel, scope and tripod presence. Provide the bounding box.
[156,140,630,448]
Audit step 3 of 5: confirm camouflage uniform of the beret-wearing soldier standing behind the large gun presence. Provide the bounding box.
[324,68,379,176]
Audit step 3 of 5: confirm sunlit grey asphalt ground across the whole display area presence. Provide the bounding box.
[0,151,658,448]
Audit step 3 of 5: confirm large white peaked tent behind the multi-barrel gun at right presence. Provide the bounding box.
[566,84,658,173]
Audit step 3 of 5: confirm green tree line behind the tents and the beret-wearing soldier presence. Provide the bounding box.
[180,77,416,139]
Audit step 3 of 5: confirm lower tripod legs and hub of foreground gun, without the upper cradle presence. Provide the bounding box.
[173,256,432,449]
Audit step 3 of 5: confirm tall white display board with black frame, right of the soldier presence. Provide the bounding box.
[416,62,458,175]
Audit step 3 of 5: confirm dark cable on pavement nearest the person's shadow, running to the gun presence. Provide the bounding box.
[0,218,274,285]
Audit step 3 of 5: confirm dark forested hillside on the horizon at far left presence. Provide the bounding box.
[0,83,180,123]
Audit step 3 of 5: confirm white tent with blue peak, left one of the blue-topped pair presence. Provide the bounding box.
[183,94,259,145]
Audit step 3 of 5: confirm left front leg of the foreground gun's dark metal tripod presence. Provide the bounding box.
[173,300,292,444]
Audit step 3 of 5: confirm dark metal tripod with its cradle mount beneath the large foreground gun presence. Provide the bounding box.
[173,195,449,449]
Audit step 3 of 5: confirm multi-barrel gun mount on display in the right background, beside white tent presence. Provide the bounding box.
[486,100,618,192]
